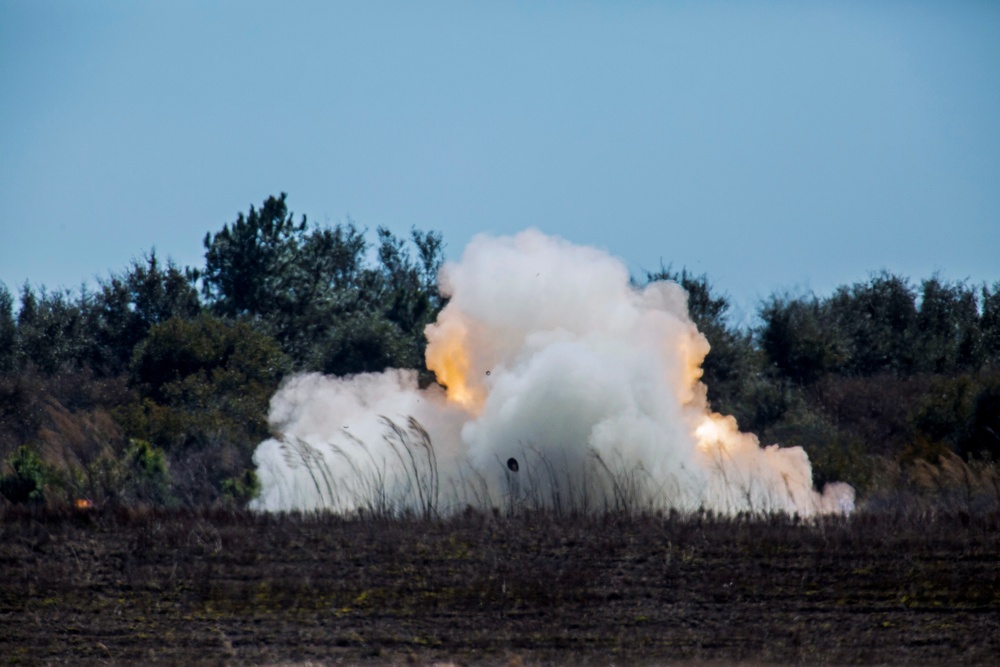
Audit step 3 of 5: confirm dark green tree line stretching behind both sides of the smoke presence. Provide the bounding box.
[0,194,1000,506]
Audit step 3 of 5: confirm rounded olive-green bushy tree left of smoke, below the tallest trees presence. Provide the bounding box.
[118,314,289,503]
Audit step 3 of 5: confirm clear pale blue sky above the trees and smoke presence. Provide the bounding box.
[0,0,1000,320]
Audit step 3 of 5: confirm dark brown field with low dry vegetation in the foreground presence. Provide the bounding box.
[0,509,1000,665]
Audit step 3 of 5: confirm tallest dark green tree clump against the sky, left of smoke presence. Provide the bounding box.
[200,194,443,374]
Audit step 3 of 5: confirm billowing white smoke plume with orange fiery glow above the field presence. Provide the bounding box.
[254,230,854,515]
